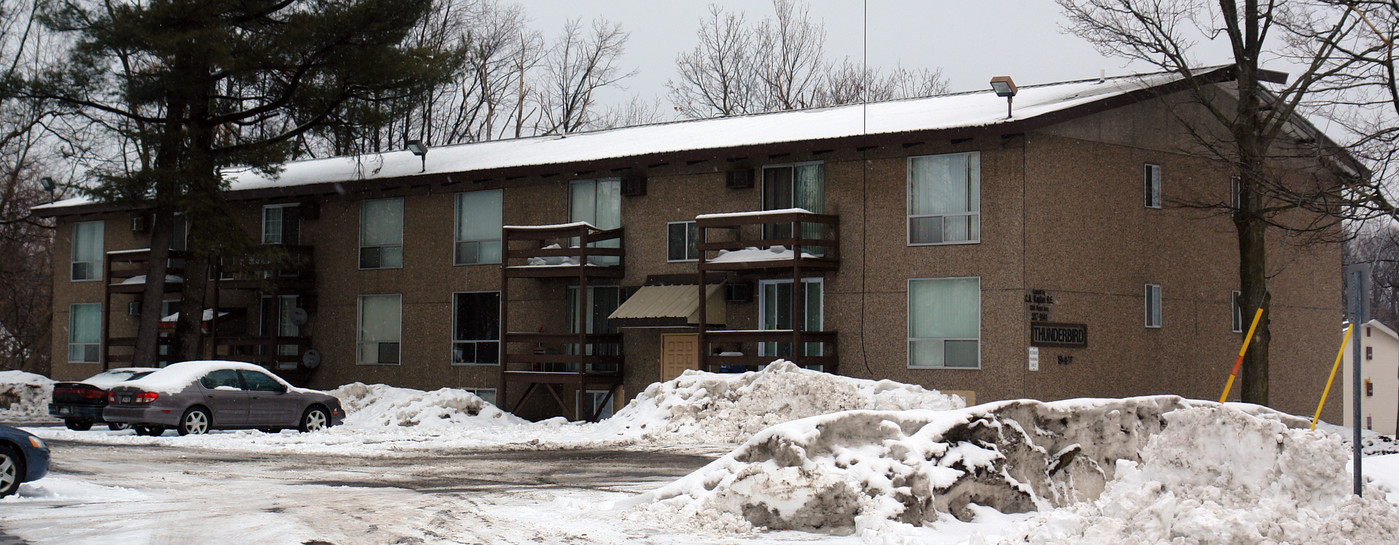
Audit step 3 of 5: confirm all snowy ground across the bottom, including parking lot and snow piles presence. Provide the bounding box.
[8,362,1399,545]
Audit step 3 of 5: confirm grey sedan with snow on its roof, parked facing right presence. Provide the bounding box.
[102,361,346,436]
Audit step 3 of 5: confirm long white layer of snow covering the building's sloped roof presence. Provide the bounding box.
[34,67,1247,212]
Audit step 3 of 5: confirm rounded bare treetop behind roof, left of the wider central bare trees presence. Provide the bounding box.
[537,20,635,134]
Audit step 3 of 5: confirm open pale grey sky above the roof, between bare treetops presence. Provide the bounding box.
[522,0,1228,113]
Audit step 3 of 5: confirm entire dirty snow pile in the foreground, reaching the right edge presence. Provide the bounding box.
[627,397,1399,544]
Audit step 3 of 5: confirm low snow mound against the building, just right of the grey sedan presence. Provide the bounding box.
[329,383,529,428]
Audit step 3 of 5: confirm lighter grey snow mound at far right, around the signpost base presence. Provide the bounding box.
[1010,405,1399,545]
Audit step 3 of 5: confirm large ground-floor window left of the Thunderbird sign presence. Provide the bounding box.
[908,277,981,369]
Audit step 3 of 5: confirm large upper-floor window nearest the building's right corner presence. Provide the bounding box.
[908,152,981,245]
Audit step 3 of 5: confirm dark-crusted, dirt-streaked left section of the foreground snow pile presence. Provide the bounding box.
[630,395,1189,531]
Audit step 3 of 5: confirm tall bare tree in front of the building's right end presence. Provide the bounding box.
[1058,0,1356,404]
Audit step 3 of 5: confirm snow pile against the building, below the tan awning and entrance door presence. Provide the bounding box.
[599,361,965,443]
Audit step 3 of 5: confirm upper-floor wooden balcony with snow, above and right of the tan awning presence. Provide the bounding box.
[695,208,841,273]
